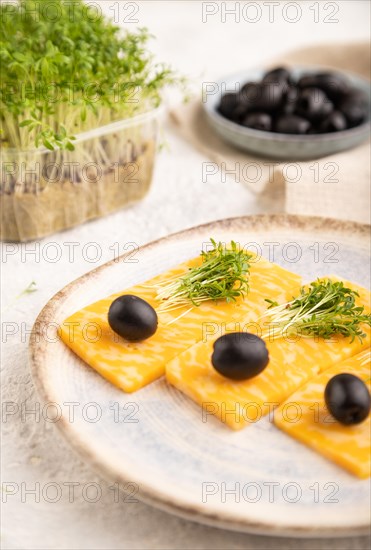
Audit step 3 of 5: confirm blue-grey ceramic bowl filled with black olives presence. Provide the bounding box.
[204,67,371,160]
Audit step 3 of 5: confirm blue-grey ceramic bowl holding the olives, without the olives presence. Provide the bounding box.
[203,66,371,160]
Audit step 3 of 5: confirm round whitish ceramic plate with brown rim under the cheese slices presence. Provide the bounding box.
[30,215,370,537]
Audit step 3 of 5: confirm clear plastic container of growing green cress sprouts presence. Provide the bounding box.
[0,0,183,240]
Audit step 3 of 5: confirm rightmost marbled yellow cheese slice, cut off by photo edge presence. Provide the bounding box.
[274,349,371,478]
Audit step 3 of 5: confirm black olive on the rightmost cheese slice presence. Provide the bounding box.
[325,373,371,426]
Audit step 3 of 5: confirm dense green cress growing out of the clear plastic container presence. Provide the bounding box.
[0,0,182,151]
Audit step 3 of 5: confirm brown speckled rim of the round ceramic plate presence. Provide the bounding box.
[28,214,370,538]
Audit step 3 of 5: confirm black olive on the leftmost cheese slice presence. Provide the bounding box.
[108,294,158,342]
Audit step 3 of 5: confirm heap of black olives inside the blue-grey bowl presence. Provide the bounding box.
[217,67,369,135]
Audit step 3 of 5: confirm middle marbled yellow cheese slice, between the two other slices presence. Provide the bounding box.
[166,277,370,430]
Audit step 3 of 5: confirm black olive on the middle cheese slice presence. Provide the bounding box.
[211,332,269,380]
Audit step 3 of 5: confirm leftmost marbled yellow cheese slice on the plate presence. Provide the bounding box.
[59,255,301,392]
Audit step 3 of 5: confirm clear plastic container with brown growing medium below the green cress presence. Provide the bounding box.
[0,108,162,241]
